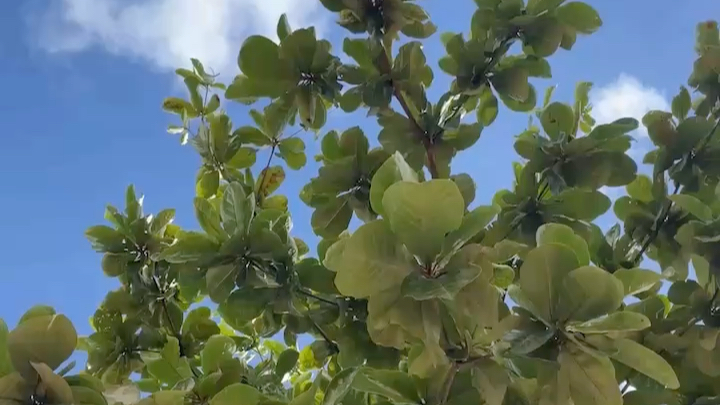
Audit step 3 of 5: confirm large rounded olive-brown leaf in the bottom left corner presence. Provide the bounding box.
[7,315,77,381]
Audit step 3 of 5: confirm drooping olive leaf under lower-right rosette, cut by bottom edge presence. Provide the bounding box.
[558,343,623,405]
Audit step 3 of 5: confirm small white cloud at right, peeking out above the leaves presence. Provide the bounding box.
[590,73,670,136]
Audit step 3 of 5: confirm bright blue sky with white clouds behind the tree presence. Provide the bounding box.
[0,0,720,333]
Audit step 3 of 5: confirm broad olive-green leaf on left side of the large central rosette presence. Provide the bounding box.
[323,220,413,298]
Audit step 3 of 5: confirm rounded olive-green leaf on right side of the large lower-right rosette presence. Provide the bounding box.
[556,266,625,321]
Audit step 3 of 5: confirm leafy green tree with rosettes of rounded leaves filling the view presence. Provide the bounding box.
[0,0,720,405]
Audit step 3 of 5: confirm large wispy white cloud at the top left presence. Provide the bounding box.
[30,0,330,76]
